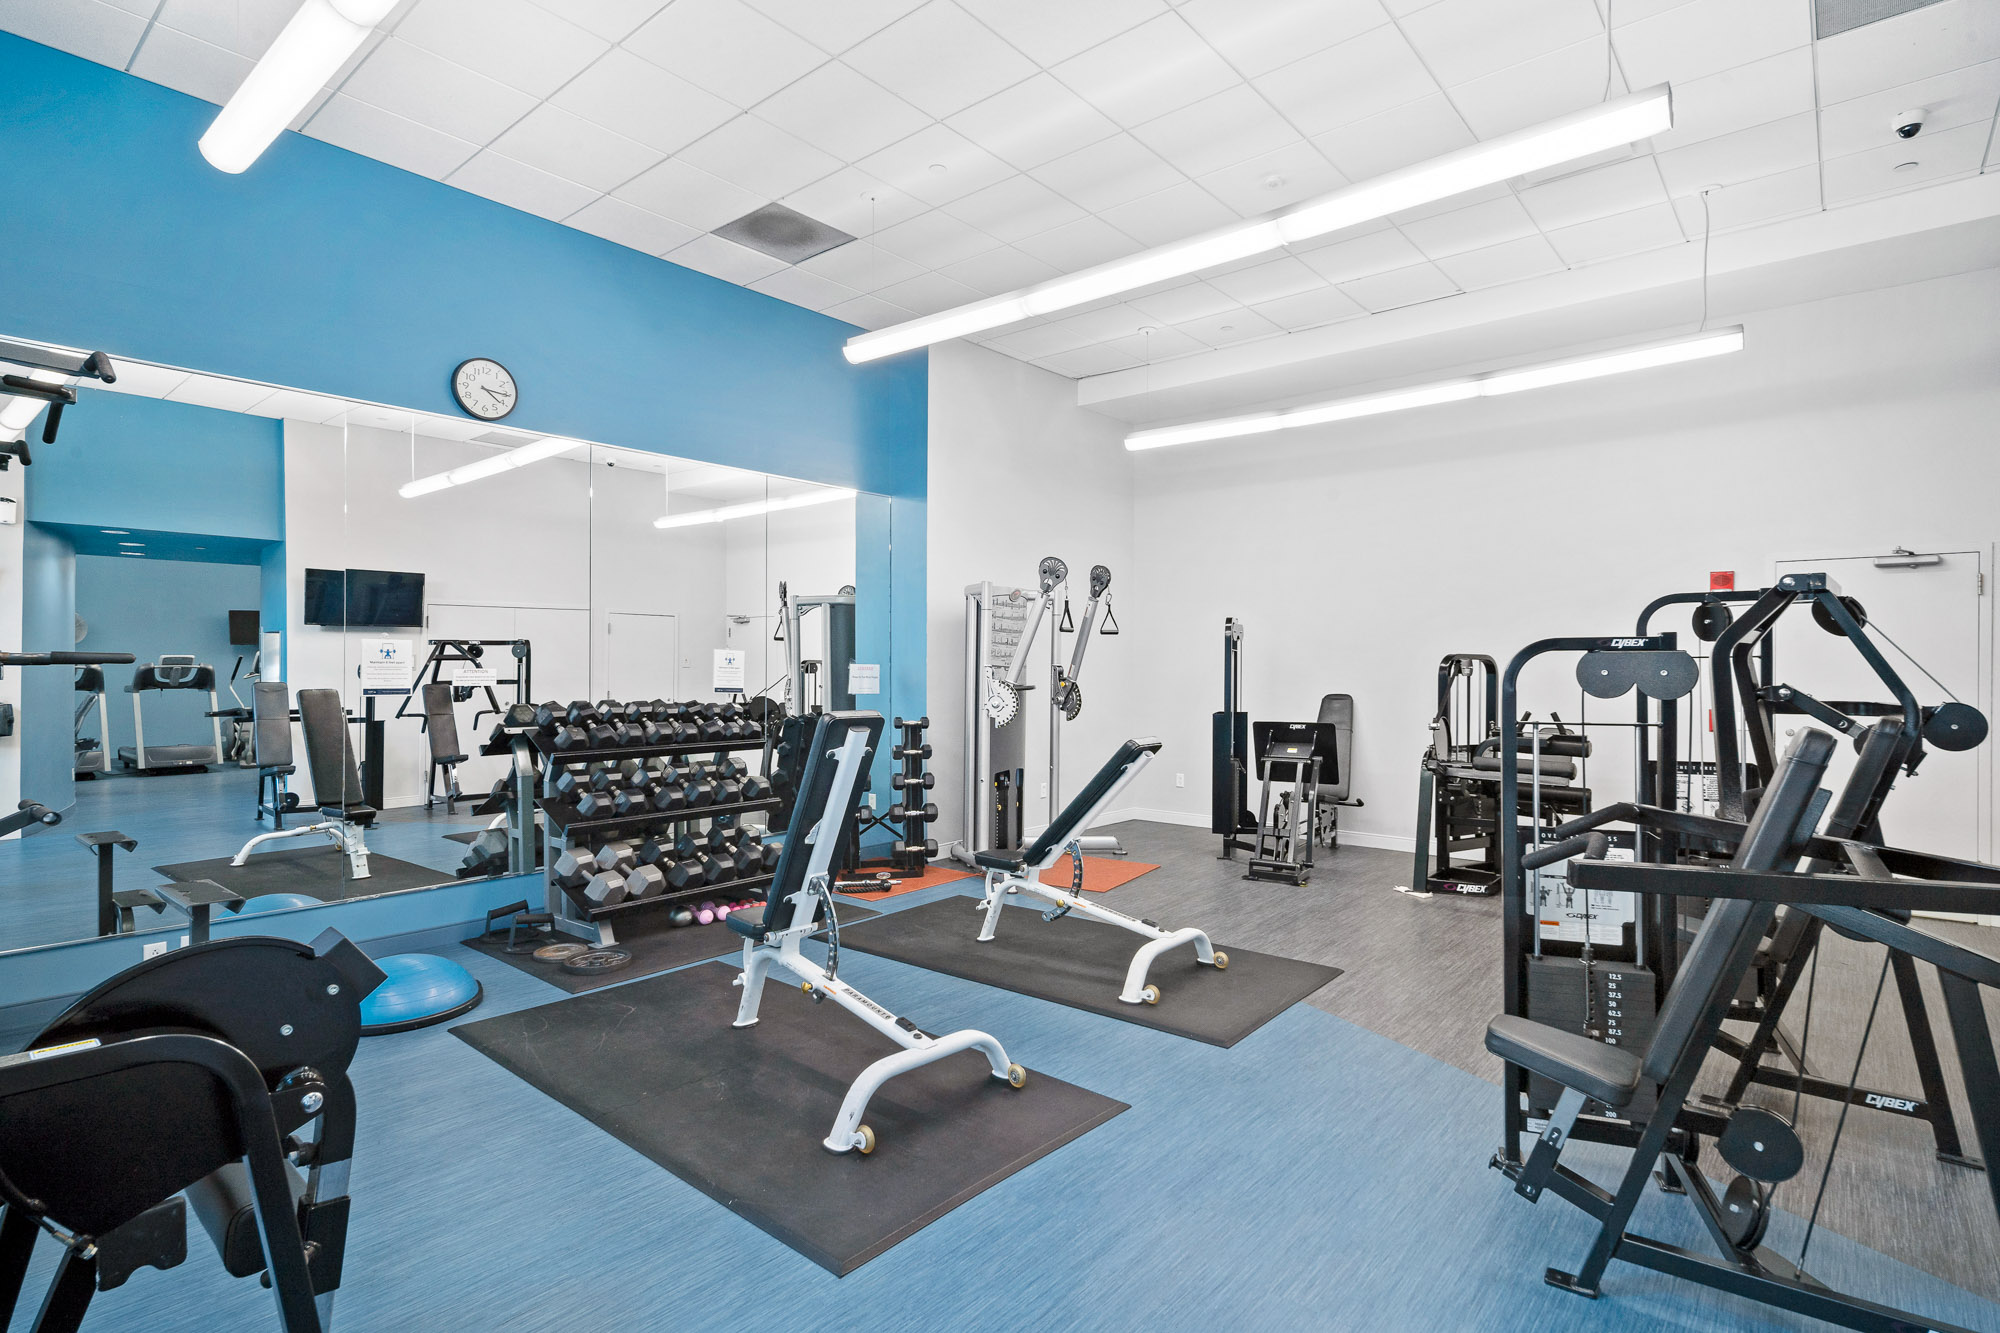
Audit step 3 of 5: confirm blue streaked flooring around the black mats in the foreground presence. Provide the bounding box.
[20,876,2000,1333]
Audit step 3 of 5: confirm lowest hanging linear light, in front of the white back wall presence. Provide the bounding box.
[1126,326,1744,450]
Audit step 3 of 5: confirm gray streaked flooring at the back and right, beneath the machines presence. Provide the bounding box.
[1096,823,2000,1299]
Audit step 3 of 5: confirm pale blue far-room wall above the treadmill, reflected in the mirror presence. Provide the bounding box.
[75,548,260,763]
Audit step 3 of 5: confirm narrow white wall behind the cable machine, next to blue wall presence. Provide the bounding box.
[926,342,1144,845]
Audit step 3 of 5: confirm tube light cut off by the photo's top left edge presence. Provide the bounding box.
[202,0,396,174]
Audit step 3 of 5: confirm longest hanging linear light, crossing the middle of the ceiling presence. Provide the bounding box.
[842,84,1674,364]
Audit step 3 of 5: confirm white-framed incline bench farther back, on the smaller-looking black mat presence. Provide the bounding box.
[972,737,1230,1005]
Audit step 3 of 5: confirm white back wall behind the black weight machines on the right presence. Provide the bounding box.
[1128,270,2000,855]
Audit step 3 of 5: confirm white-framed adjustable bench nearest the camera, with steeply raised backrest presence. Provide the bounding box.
[726,713,1028,1153]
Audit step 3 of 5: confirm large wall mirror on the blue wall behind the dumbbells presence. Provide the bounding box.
[0,340,896,964]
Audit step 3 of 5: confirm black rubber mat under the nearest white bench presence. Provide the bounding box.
[452,967,1128,1275]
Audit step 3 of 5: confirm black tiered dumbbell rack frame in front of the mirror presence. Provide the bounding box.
[530,729,778,949]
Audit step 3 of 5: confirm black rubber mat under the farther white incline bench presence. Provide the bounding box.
[840,897,1340,1047]
